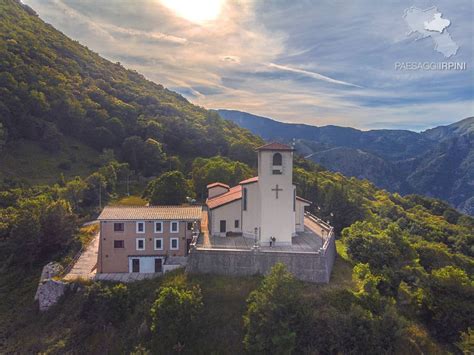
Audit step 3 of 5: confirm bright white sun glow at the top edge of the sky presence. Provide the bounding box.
[160,0,225,24]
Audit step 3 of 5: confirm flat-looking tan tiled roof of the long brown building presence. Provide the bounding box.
[97,206,202,221]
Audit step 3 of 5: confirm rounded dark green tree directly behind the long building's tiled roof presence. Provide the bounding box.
[147,171,190,205]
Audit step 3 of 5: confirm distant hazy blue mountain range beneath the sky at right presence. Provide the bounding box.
[217,110,474,215]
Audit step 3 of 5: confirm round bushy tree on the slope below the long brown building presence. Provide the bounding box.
[150,286,203,346]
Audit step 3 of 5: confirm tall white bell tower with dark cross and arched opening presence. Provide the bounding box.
[257,143,296,246]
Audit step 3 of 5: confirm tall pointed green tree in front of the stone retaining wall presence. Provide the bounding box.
[244,263,304,354]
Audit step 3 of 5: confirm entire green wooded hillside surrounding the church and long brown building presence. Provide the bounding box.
[0,0,474,354]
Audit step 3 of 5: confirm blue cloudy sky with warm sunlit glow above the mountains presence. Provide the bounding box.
[23,0,474,131]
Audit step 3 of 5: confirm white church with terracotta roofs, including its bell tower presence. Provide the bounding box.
[206,143,311,246]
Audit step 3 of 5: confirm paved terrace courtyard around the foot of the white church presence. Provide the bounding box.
[196,217,324,252]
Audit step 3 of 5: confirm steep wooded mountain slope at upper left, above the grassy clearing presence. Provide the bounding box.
[0,0,259,184]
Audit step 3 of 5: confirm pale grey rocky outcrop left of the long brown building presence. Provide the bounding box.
[35,262,69,311]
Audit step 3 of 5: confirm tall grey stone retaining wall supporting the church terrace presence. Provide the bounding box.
[186,236,336,283]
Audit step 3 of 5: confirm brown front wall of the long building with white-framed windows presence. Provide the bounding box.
[97,221,200,273]
